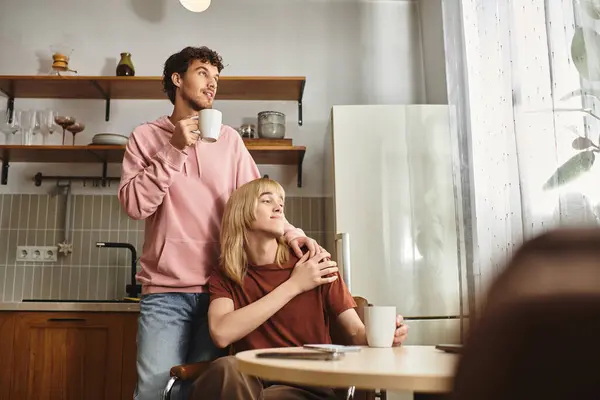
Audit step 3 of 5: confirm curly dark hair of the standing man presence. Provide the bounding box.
[163,46,224,104]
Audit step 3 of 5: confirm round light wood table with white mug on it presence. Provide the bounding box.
[236,346,458,393]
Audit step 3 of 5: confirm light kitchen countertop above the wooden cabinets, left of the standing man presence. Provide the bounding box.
[0,300,140,312]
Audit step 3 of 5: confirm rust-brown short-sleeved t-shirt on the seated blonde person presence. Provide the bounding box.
[209,254,356,353]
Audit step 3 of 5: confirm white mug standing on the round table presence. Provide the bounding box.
[364,306,396,347]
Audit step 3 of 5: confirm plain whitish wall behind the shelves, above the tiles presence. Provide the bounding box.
[0,0,440,196]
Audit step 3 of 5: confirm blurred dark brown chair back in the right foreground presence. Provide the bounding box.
[451,230,600,400]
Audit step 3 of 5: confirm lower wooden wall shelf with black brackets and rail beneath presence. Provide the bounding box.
[0,144,306,187]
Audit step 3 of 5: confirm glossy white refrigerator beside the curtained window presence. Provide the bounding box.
[331,105,467,345]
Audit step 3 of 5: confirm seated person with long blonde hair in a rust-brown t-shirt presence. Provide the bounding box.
[190,178,408,400]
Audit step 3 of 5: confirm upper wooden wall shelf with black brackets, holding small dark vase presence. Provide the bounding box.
[0,75,306,125]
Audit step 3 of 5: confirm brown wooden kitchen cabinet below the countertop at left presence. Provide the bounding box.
[0,312,137,400]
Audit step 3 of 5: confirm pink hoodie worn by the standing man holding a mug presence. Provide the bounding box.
[118,116,304,294]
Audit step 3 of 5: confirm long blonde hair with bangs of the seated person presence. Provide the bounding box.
[220,178,289,286]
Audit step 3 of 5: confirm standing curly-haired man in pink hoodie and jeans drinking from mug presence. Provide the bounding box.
[118,47,319,400]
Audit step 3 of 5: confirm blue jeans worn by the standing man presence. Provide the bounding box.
[134,293,226,400]
